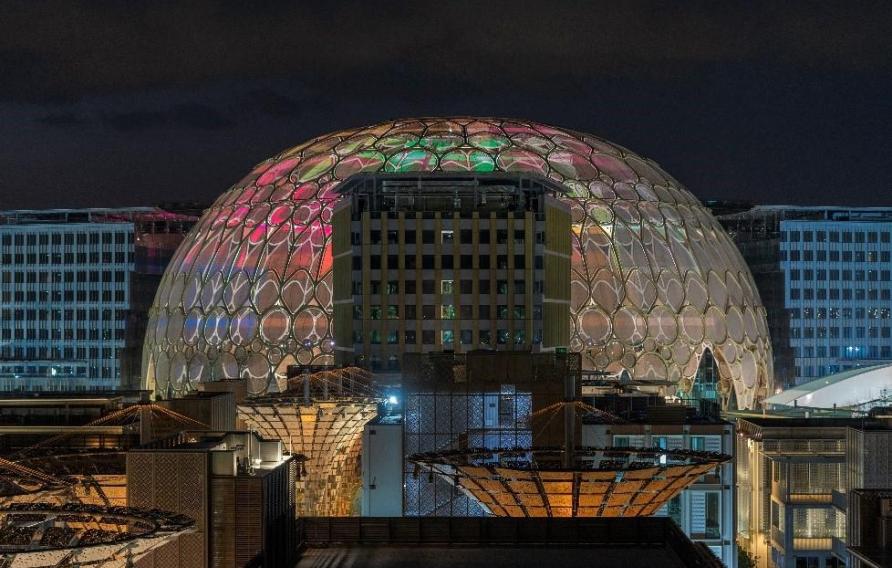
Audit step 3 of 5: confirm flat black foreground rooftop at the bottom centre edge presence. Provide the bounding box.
[298,517,723,568]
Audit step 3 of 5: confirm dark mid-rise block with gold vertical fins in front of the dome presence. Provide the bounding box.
[332,174,570,373]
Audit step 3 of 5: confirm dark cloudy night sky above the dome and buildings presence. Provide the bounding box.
[0,0,892,209]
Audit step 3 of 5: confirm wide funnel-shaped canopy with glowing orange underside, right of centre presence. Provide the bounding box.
[409,448,730,517]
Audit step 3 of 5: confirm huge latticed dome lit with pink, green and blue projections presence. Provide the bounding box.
[143,117,772,407]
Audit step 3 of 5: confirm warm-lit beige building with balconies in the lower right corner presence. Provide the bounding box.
[737,415,892,568]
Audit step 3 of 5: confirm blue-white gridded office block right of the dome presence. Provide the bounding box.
[719,206,892,386]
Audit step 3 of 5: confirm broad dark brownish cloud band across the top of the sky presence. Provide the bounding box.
[0,0,892,101]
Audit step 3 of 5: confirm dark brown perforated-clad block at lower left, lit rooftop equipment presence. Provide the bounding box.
[127,432,297,568]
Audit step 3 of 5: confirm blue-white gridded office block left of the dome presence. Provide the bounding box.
[0,208,195,391]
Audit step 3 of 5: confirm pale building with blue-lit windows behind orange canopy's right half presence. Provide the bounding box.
[582,395,737,568]
